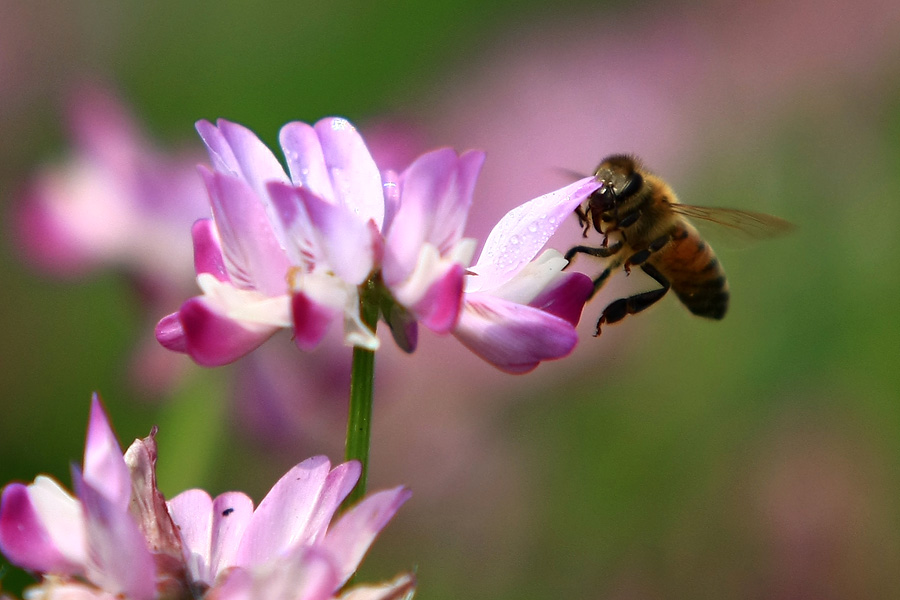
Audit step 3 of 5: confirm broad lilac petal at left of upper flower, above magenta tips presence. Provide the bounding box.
[201,169,290,296]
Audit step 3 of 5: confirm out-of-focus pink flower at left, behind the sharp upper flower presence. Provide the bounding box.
[11,86,209,390]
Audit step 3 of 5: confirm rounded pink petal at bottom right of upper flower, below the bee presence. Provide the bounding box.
[453,294,578,373]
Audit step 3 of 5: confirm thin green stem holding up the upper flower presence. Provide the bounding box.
[344,282,378,508]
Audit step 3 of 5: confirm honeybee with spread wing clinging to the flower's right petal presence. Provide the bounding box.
[566,154,793,336]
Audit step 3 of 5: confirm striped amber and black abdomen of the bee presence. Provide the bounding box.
[653,224,729,319]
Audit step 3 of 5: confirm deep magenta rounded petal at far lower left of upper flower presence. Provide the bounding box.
[171,296,279,367]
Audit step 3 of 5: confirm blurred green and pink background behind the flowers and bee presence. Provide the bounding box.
[0,0,900,600]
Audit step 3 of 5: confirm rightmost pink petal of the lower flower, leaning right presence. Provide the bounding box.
[324,487,412,585]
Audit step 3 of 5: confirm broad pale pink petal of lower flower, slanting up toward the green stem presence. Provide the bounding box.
[235,456,331,567]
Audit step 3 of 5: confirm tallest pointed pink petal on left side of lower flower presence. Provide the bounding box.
[84,394,131,510]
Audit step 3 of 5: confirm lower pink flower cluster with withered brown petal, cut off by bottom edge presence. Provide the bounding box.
[0,396,415,600]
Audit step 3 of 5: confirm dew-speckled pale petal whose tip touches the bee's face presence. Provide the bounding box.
[470,177,600,291]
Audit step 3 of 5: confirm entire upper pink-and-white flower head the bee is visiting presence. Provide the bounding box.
[157,118,597,372]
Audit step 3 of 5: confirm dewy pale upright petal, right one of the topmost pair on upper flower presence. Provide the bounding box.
[315,117,384,229]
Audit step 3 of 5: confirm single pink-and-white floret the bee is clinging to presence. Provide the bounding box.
[453,177,598,373]
